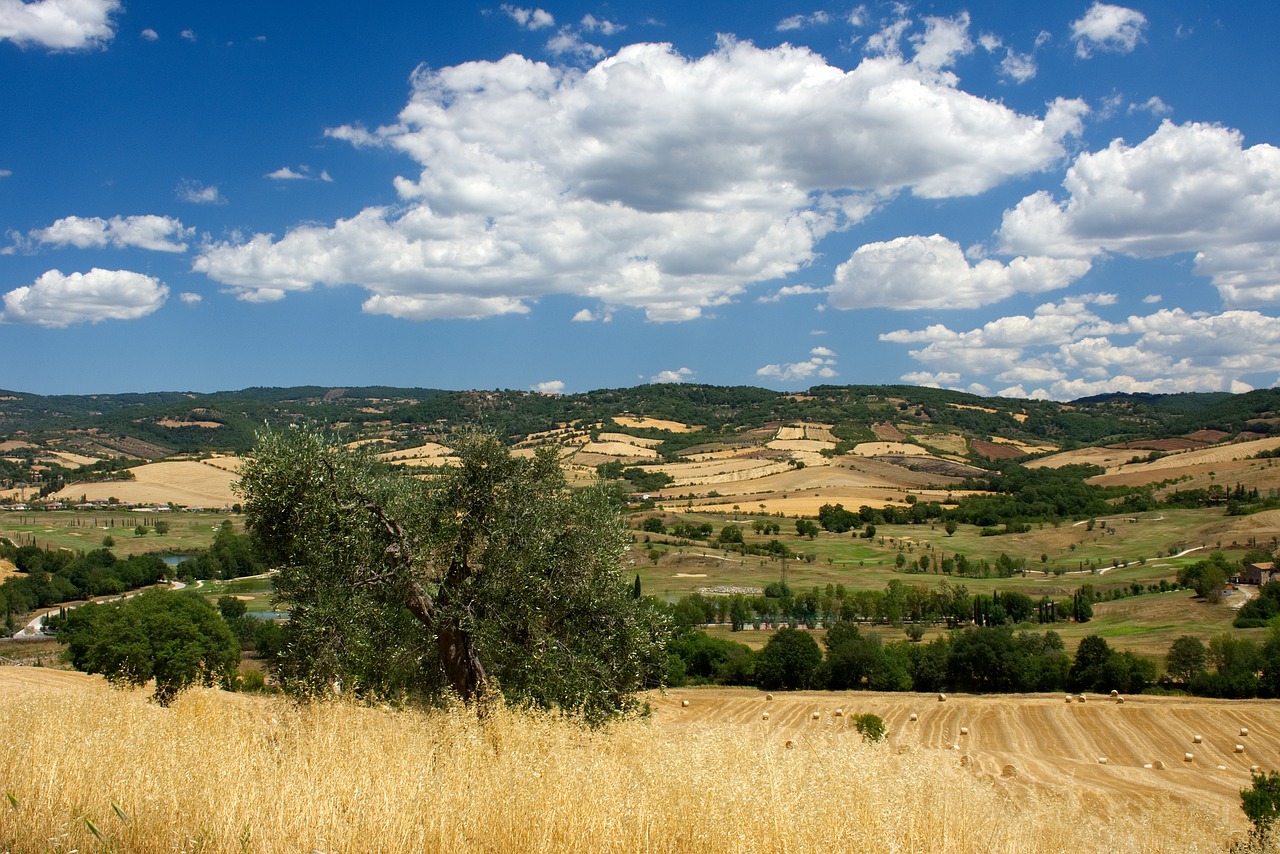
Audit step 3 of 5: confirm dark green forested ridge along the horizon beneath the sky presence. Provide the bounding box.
[0,384,1280,458]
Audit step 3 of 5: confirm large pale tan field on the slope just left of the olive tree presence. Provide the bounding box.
[55,457,239,507]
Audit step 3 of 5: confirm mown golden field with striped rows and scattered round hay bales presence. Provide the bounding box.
[652,688,1280,819]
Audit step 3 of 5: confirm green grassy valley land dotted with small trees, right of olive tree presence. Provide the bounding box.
[627,504,1280,598]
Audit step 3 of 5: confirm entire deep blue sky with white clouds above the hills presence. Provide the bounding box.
[0,0,1280,399]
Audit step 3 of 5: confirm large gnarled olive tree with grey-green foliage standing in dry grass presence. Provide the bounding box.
[238,429,666,720]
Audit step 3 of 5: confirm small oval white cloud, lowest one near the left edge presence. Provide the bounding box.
[0,268,169,326]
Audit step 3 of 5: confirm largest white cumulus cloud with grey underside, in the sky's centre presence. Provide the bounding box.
[196,35,1085,321]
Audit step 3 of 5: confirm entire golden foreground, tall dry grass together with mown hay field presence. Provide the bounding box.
[0,667,1280,854]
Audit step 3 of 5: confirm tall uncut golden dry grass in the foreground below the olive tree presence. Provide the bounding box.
[0,684,1254,854]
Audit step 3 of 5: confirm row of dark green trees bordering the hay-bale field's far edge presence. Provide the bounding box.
[667,622,1280,699]
